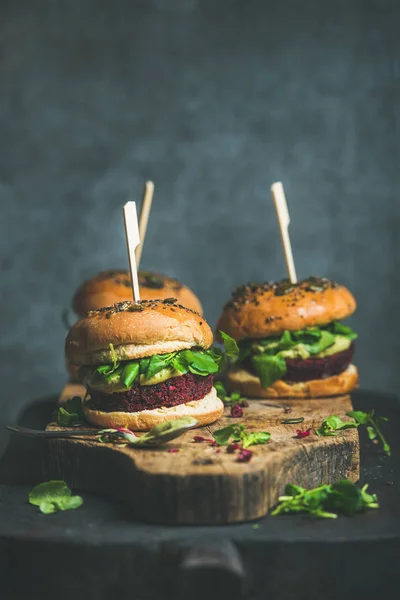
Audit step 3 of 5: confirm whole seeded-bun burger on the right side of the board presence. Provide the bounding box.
[217,277,358,398]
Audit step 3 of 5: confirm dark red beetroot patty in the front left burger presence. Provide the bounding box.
[88,373,213,412]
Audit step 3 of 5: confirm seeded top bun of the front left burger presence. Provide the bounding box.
[65,298,213,365]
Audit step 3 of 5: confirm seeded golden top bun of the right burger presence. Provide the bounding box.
[217,277,356,341]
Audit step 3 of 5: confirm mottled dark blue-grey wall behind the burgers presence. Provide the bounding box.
[0,0,400,450]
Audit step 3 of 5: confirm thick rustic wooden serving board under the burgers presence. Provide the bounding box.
[42,384,359,524]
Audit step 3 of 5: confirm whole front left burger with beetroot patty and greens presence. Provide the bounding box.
[65,298,224,430]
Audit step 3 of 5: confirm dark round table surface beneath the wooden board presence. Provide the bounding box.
[0,391,400,600]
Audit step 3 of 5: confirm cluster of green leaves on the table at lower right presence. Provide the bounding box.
[271,479,379,519]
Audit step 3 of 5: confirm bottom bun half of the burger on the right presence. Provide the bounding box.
[225,365,358,398]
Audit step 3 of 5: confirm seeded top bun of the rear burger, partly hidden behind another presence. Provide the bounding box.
[72,270,203,317]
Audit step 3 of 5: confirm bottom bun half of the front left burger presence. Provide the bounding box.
[83,388,224,431]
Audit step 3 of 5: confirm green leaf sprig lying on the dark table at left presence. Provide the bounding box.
[29,481,83,515]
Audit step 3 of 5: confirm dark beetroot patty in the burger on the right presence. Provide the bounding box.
[282,344,354,383]
